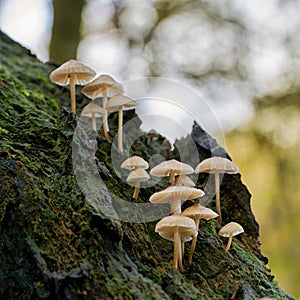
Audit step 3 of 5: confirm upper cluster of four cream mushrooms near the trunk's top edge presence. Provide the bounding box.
[50,59,136,152]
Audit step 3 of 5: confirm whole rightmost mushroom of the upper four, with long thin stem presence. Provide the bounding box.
[106,94,136,152]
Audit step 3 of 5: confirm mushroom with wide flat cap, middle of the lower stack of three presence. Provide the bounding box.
[149,186,204,215]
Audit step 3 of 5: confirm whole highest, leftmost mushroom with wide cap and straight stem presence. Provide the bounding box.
[50,59,96,114]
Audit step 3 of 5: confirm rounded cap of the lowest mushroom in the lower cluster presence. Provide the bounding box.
[155,215,198,242]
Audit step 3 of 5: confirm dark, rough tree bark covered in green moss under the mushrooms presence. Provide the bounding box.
[0,33,292,299]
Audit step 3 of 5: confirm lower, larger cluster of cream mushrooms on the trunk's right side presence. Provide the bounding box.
[121,156,244,272]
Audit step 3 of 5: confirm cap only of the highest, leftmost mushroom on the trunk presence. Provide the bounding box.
[50,59,96,86]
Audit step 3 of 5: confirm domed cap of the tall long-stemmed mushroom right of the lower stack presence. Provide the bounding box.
[195,156,239,174]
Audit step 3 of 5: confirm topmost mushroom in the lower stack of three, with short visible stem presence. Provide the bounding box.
[150,159,194,185]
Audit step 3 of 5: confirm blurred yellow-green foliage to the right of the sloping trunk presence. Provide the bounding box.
[226,90,300,296]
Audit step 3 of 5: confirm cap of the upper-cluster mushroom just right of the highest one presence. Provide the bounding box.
[81,74,123,99]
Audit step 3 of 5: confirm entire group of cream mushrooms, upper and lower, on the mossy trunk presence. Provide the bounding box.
[50,59,244,271]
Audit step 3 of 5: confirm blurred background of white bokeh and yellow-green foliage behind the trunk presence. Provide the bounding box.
[0,0,300,297]
